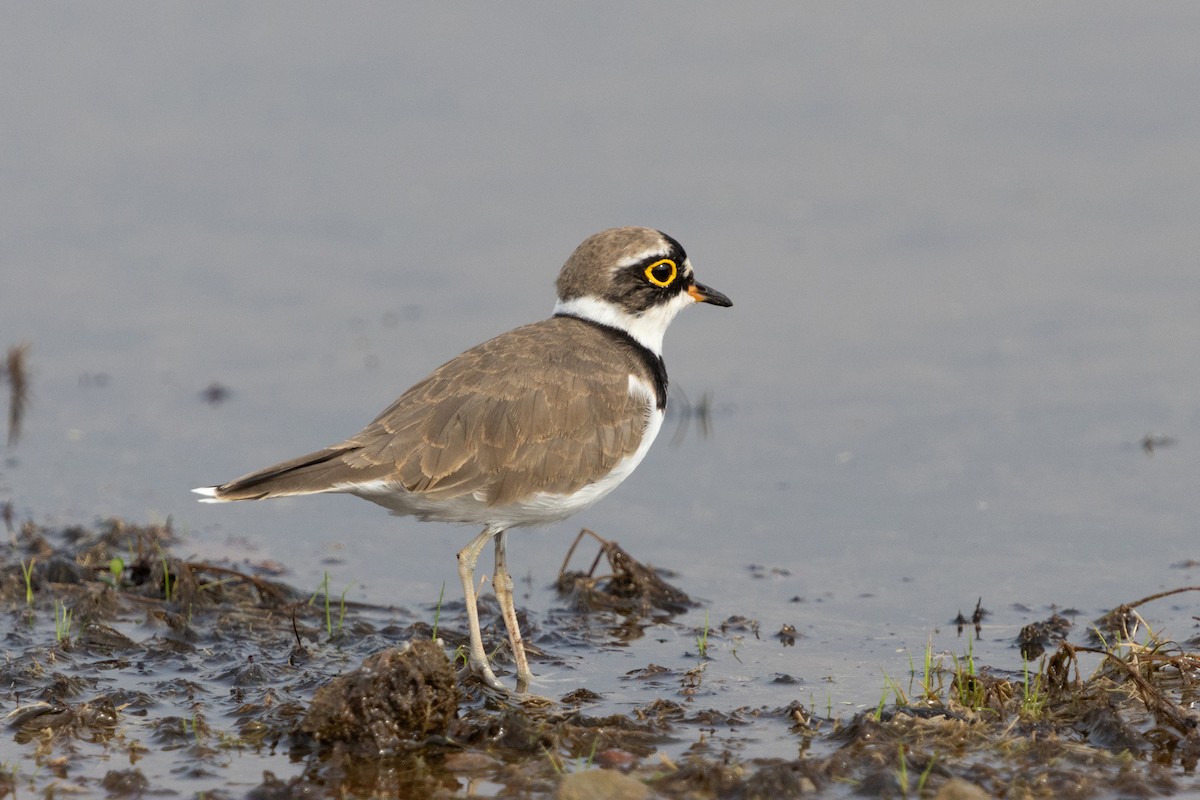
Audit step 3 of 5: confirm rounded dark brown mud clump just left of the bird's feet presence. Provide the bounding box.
[300,639,458,754]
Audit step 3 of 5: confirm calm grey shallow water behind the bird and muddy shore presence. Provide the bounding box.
[7,4,1200,796]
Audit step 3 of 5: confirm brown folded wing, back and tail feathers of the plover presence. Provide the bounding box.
[216,318,650,505]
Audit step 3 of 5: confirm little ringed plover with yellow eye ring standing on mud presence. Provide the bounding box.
[194,228,733,692]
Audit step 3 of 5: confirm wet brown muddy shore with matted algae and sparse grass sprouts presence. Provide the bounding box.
[0,512,1200,799]
